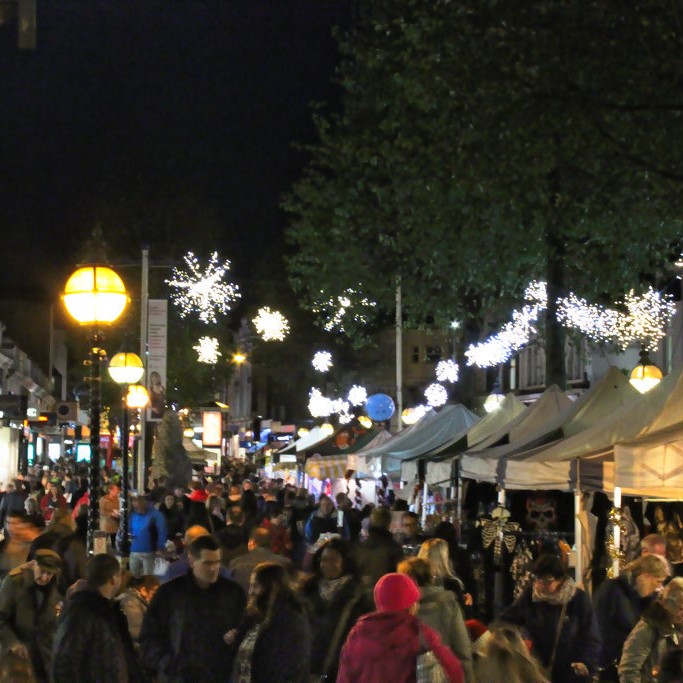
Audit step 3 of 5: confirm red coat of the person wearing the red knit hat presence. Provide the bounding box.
[337,610,464,683]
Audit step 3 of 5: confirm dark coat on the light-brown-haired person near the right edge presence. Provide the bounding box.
[593,574,654,668]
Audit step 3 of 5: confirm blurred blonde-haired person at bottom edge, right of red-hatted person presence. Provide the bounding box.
[476,625,548,683]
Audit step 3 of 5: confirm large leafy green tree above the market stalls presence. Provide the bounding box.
[285,0,683,385]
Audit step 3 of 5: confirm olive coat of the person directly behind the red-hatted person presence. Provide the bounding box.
[417,586,474,683]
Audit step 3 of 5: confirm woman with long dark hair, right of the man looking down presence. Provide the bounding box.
[232,562,311,683]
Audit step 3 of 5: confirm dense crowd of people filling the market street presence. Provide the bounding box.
[0,461,683,683]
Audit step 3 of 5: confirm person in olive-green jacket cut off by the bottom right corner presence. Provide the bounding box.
[619,577,683,683]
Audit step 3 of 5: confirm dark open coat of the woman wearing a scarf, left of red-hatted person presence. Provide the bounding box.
[301,576,375,681]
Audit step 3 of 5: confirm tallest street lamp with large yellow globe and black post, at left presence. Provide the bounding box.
[62,260,128,553]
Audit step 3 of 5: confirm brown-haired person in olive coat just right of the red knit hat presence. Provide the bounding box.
[398,557,475,683]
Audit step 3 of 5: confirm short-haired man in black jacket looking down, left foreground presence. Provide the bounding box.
[140,536,246,683]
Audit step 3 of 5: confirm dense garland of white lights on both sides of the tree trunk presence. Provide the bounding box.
[465,282,676,368]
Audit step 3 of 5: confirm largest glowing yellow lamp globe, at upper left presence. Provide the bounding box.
[62,266,128,325]
